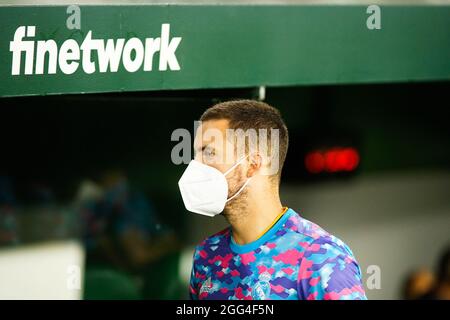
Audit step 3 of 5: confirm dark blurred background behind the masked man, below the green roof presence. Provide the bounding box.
[0,82,450,299]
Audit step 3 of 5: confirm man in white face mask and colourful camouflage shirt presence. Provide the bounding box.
[179,100,366,300]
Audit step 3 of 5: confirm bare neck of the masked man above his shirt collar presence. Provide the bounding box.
[229,194,283,245]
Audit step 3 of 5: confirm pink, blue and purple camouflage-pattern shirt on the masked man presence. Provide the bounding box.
[189,209,367,300]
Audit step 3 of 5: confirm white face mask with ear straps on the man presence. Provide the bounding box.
[178,156,251,217]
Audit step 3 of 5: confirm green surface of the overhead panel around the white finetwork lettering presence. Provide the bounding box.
[0,5,450,96]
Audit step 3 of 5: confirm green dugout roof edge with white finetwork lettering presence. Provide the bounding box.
[0,0,450,96]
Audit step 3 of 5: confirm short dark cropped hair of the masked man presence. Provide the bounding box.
[200,99,289,181]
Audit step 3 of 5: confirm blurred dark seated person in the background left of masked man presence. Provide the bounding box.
[77,170,178,272]
